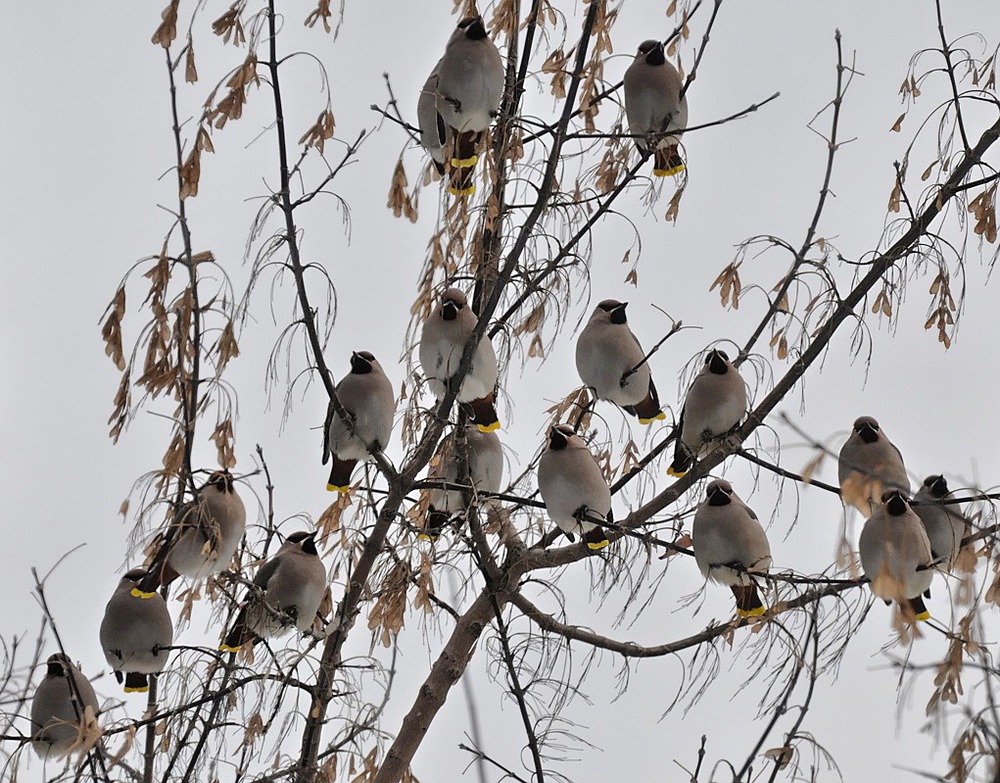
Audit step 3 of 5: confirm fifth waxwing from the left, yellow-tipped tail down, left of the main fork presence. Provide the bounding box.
[323,351,396,492]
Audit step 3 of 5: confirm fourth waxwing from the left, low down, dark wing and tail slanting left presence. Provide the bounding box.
[219,531,327,652]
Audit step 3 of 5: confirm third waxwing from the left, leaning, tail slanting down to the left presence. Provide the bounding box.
[135,470,247,598]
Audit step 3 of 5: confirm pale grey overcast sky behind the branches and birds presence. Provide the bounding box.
[0,0,1000,782]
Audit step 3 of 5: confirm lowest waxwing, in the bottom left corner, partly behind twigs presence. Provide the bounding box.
[31,653,100,759]
